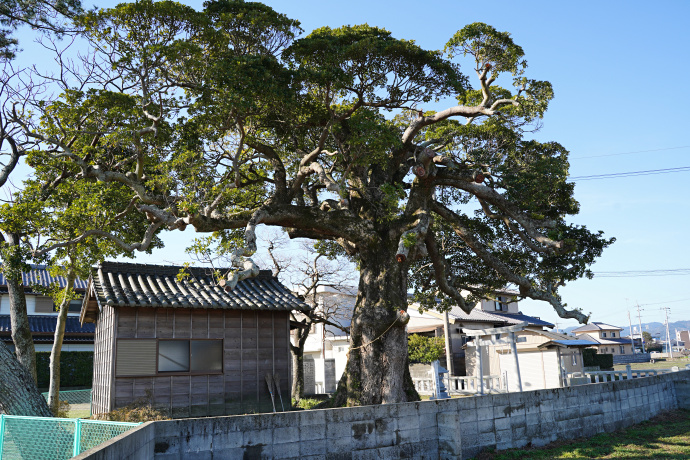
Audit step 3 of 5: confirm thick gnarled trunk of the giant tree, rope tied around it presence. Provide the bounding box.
[332,244,419,406]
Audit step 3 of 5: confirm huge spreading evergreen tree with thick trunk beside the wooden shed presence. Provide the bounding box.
[17,0,610,405]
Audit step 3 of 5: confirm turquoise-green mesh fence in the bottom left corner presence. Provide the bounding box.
[0,414,140,460]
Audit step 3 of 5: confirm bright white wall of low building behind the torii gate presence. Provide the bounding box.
[499,351,560,391]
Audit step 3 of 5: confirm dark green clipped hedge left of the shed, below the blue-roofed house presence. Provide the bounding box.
[36,351,93,388]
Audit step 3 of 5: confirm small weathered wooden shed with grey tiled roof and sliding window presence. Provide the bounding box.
[81,262,308,418]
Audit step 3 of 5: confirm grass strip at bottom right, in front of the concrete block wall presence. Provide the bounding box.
[477,410,690,460]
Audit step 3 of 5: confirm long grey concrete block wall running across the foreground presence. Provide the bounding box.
[79,371,690,460]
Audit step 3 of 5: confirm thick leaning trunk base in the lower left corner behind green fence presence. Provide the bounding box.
[0,341,52,417]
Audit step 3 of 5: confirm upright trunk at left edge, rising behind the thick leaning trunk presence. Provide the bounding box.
[4,233,37,384]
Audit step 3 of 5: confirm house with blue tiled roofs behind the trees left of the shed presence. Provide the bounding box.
[0,265,95,352]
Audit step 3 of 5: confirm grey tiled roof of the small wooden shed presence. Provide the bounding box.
[89,262,309,310]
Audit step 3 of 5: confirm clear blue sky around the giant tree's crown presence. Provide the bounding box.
[12,0,690,327]
